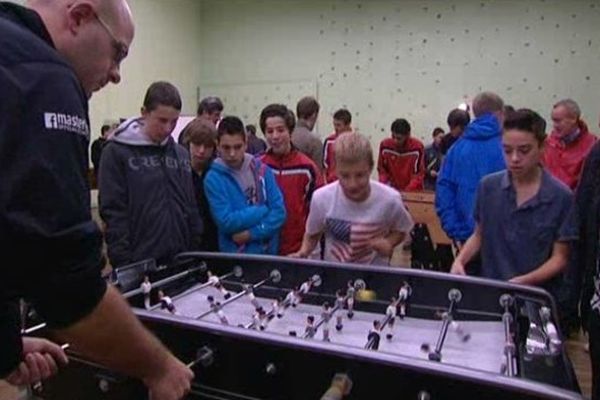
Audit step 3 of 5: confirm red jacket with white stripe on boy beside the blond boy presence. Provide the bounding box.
[261,147,324,255]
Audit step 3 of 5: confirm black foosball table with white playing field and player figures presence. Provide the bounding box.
[27,253,581,400]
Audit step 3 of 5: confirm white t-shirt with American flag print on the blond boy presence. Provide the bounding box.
[306,180,413,265]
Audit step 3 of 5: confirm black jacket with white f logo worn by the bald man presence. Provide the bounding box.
[0,3,106,376]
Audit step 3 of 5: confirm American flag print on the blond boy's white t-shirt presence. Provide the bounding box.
[326,218,383,264]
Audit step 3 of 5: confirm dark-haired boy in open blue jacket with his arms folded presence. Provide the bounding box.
[204,117,286,254]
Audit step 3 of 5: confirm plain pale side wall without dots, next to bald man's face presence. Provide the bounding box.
[90,0,202,138]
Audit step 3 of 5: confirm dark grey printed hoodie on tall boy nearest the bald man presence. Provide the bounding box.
[99,118,202,267]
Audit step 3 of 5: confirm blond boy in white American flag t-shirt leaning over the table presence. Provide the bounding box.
[293,132,413,265]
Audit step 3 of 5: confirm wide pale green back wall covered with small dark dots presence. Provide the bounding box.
[199,0,600,142]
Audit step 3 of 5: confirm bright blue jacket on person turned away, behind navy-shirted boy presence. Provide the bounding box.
[435,113,506,242]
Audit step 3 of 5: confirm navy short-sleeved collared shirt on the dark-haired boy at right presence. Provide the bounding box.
[475,170,578,284]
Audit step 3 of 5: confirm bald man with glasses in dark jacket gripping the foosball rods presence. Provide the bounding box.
[0,0,193,400]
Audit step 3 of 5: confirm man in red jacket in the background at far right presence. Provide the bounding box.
[542,99,597,189]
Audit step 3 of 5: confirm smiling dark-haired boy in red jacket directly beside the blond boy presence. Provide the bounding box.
[260,104,323,255]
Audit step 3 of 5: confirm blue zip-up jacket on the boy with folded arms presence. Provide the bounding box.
[204,154,286,254]
